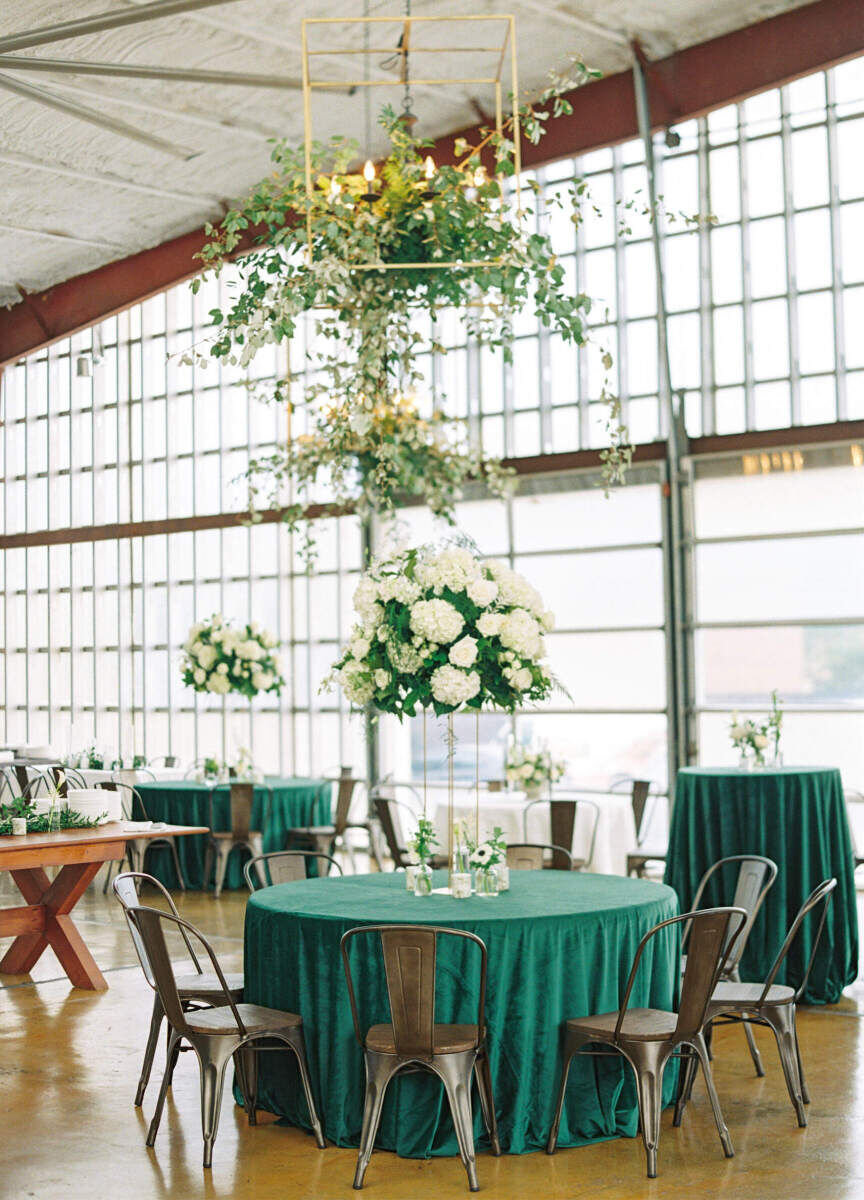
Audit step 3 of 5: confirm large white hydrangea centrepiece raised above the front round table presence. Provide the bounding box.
[325,546,554,720]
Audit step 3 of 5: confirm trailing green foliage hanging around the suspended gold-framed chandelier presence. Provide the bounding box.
[187,62,632,552]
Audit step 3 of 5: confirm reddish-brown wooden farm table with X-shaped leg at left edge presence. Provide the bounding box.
[0,821,206,991]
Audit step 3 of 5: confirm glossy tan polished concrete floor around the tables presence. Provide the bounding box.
[0,876,864,1200]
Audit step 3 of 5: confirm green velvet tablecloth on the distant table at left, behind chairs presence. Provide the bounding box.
[137,779,332,888]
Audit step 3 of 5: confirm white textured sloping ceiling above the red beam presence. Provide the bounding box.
[0,0,805,305]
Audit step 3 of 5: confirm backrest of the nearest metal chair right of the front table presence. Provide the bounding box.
[614,907,748,1040]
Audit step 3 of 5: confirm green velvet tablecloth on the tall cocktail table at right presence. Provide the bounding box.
[665,767,858,1004]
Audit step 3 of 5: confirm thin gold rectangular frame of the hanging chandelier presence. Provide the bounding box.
[300,13,522,271]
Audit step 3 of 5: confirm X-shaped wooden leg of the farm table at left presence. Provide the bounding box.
[0,859,108,991]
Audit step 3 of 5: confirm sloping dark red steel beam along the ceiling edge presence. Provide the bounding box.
[0,0,864,367]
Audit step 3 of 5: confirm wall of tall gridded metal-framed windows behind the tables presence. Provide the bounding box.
[0,59,864,779]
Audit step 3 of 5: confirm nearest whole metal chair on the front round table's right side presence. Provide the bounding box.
[546,908,748,1180]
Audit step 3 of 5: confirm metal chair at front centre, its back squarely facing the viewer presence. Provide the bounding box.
[341,925,500,1192]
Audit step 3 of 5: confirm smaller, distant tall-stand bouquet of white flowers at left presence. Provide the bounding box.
[181,613,284,700]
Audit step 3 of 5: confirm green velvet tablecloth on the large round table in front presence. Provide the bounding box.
[245,871,679,1158]
